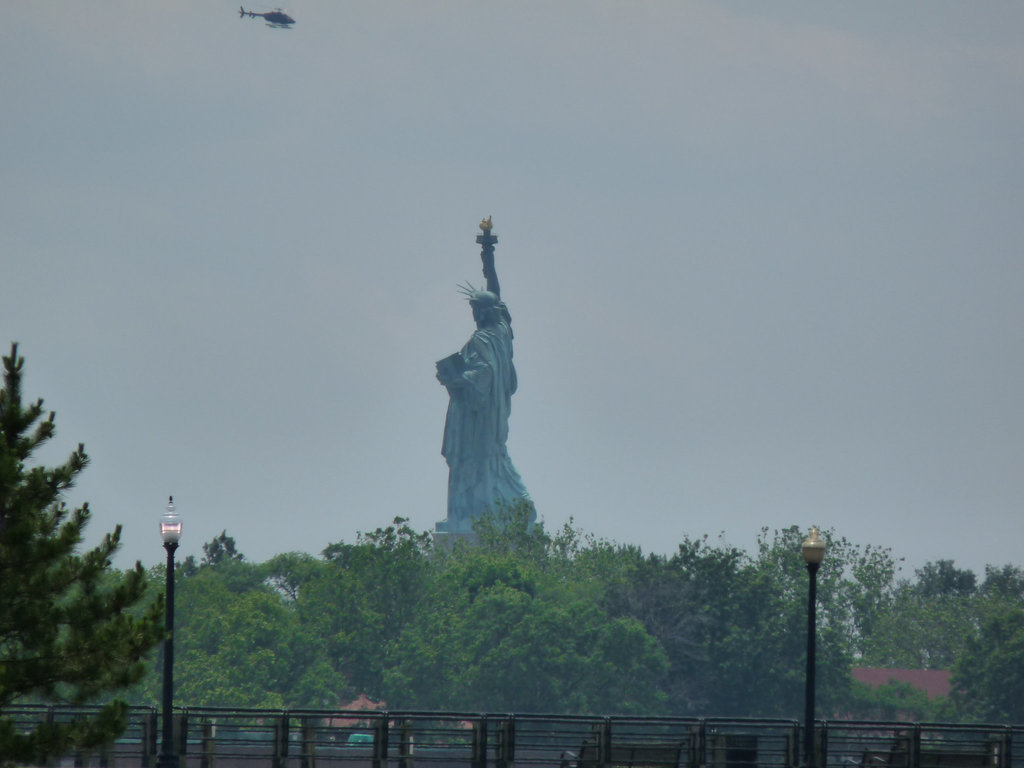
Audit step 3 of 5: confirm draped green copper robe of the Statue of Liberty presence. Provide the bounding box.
[441,321,529,531]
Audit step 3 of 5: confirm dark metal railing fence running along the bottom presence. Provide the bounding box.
[4,707,1024,768]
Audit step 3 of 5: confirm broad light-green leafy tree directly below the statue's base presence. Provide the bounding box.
[384,521,669,714]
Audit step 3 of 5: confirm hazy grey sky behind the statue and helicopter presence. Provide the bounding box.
[0,0,1024,572]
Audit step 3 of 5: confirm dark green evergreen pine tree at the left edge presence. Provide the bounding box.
[0,344,163,766]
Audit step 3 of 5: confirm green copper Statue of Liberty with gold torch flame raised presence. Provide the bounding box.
[437,217,536,534]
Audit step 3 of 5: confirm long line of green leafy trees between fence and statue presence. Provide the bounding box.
[123,509,1024,723]
